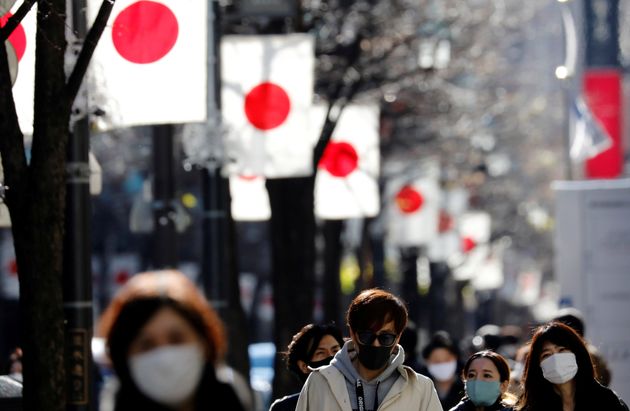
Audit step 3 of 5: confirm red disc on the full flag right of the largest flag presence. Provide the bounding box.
[245,82,291,130]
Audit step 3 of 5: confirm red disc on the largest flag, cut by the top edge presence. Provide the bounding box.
[112,1,179,64]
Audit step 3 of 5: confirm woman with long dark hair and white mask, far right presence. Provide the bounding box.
[515,321,628,411]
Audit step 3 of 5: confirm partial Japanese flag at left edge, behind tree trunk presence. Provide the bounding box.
[0,2,37,135]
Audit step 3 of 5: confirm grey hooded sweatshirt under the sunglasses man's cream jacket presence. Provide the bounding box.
[330,340,405,411]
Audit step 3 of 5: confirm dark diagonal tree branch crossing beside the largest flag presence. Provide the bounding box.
[65,0,115,105]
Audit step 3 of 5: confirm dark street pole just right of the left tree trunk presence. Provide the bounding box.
[62,0,94,411]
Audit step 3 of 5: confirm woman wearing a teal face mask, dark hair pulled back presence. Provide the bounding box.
[450,350,516,411]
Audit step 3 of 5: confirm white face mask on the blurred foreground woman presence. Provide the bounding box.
[129,344,205,407]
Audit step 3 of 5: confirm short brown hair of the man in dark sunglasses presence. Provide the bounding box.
[346,288,408,334]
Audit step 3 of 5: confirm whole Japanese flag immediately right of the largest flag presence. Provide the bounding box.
[221,34,315,178]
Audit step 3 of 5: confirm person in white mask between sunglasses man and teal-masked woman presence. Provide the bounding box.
[420,330,464,410]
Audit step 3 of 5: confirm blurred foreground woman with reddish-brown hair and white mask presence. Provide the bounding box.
[98,270,243,411]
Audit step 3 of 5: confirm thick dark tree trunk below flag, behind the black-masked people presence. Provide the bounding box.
[267,176,315,398]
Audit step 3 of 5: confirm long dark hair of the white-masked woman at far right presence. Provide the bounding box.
[516,321,595,410]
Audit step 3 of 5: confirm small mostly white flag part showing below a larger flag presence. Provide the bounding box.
[230,176,271,221]
